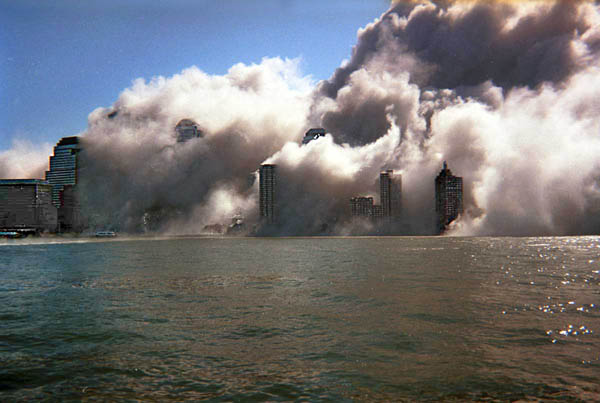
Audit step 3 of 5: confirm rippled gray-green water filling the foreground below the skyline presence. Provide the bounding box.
[0,237,600,401]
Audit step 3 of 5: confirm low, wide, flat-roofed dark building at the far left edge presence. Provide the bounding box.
[0,179,57,233]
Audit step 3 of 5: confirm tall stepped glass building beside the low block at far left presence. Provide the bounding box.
[46,136,81,208]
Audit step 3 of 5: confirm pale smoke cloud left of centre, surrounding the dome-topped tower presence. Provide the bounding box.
[81,59,312,233]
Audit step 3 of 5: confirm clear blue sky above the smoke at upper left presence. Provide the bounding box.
[0,0,389,151]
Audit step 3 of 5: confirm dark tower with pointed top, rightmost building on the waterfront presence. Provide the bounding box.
[435,161,463,233]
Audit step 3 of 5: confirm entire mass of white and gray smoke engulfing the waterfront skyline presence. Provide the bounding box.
[0,0,600,235]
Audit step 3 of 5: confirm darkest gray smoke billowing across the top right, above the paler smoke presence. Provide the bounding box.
[312,0,600,148]
